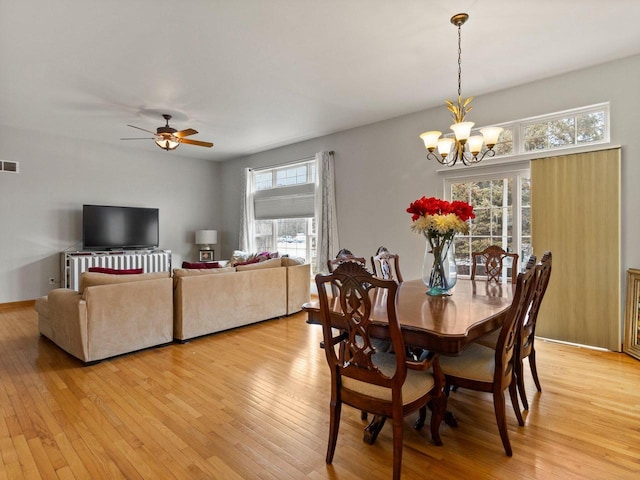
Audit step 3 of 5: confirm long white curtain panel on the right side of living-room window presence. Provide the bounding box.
[315,152,339,273]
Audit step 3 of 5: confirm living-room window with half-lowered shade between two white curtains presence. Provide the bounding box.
[253,160,316,265]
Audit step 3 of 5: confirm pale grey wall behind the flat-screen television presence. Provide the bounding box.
[0,128,222,303]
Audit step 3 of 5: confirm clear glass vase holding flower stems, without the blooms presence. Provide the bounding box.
[422,235,458,296]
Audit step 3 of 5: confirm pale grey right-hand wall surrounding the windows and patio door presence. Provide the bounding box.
[222,56,640,279]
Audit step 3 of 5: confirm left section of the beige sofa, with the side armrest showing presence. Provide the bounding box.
[36,272,173,363]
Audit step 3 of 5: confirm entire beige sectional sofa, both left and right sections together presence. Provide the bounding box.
[36,258,310,363]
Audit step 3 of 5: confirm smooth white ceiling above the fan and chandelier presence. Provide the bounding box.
[0,0,640,161]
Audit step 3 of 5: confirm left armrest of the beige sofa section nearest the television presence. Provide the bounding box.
[47,288,88,361]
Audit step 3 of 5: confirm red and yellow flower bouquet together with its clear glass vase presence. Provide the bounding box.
[407,197,476,295]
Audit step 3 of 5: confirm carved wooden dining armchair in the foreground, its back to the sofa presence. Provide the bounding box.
[315,262,447,479]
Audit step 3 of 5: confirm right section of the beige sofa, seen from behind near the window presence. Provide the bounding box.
[173,257,311,341]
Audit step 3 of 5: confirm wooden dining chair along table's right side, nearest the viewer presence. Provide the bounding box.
[440,269,538,457]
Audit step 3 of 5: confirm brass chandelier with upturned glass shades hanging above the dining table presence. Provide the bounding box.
[420,13,503,167]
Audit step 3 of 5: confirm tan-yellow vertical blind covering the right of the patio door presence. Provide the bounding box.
[531,148,621,351]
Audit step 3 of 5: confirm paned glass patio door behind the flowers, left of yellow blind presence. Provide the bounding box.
[446,170,532,276]
